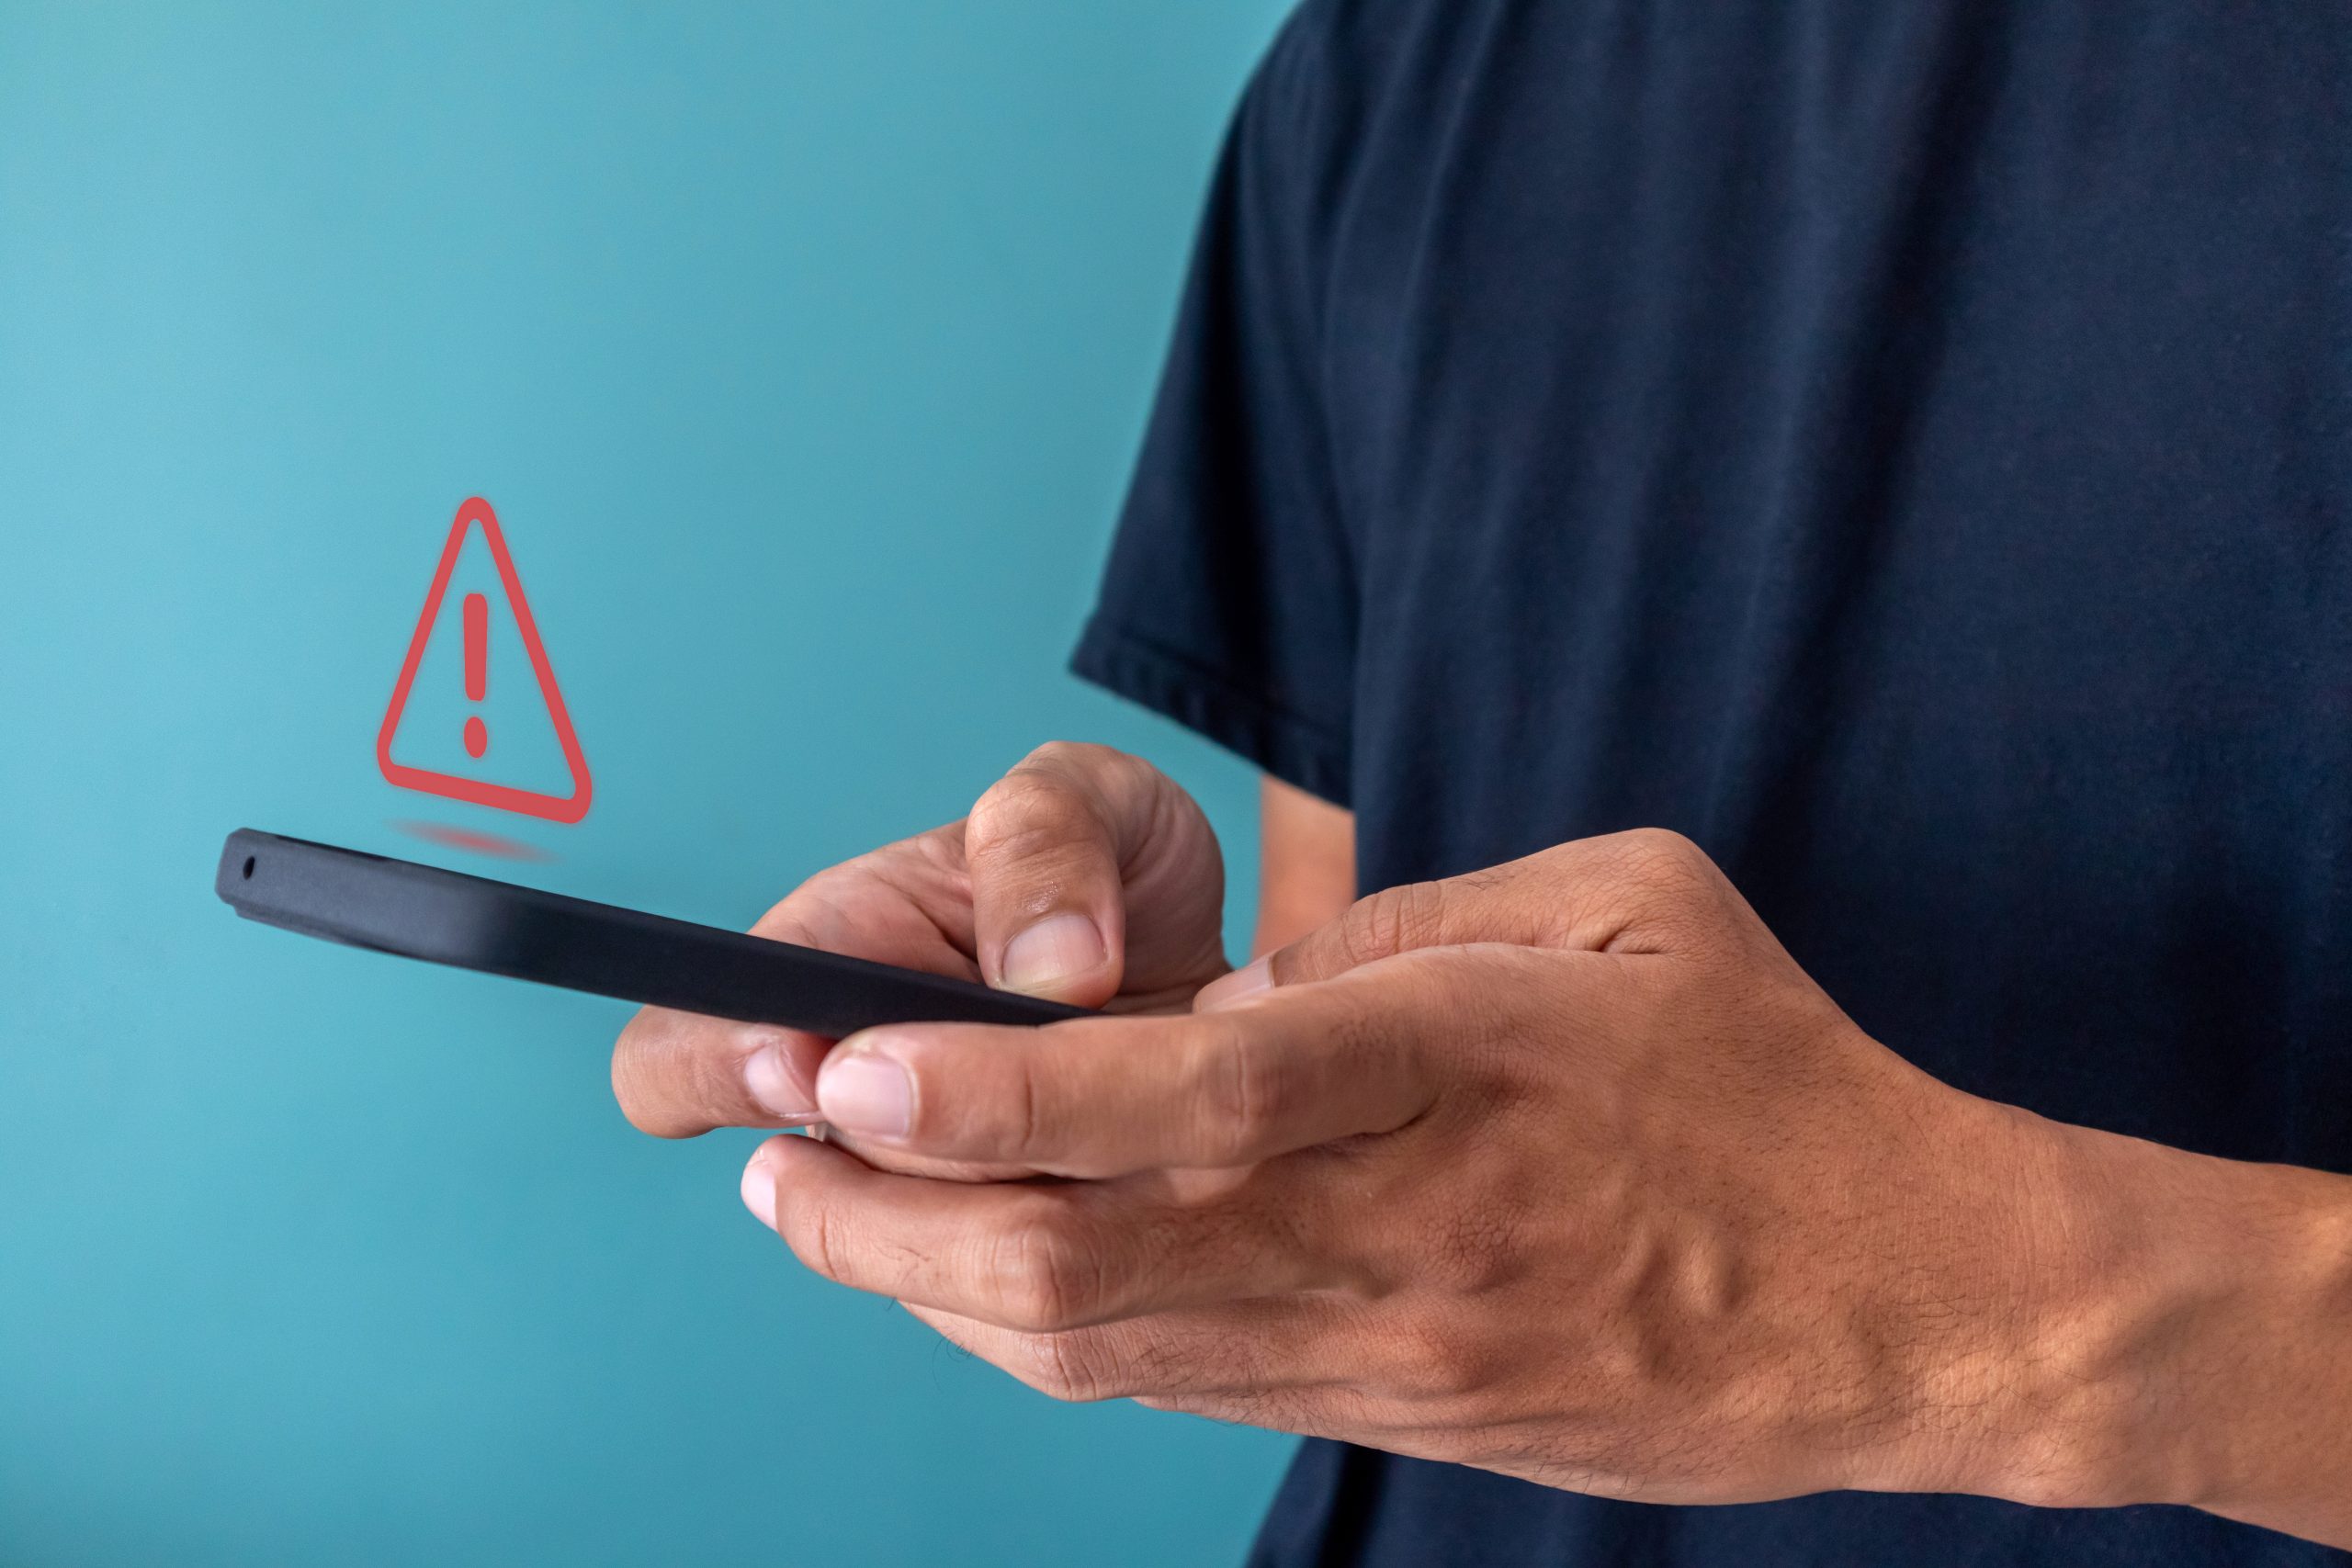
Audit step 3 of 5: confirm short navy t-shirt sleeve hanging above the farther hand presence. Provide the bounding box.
[1070,17,1357,804]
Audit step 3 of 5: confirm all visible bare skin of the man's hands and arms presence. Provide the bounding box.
[614,745,2352,1544]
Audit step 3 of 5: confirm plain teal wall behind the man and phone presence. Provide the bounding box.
[0,0,1289,1568]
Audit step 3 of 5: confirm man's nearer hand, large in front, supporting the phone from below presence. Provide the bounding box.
[743,832,2154,1502]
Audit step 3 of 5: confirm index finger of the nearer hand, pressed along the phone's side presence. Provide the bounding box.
[816,959,1439,1178]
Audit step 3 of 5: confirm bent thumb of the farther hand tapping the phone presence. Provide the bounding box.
[965,740,1221,1006]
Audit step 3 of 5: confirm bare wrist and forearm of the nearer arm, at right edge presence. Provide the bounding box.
[1985,1123,2352,1547]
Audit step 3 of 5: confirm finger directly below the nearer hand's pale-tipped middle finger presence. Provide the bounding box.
[908,1295,1350,1404]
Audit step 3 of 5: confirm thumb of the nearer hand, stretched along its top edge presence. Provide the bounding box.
[1193,828,1729,1009]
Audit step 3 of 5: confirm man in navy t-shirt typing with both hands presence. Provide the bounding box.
[614,0,2352,1568]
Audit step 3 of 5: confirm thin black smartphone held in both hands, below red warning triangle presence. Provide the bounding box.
[214,828,1087,1039]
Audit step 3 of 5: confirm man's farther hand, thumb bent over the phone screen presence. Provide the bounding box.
[612,740,1227,1176]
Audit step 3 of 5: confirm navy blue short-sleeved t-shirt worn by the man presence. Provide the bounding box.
[1075,0,2352,1568]
